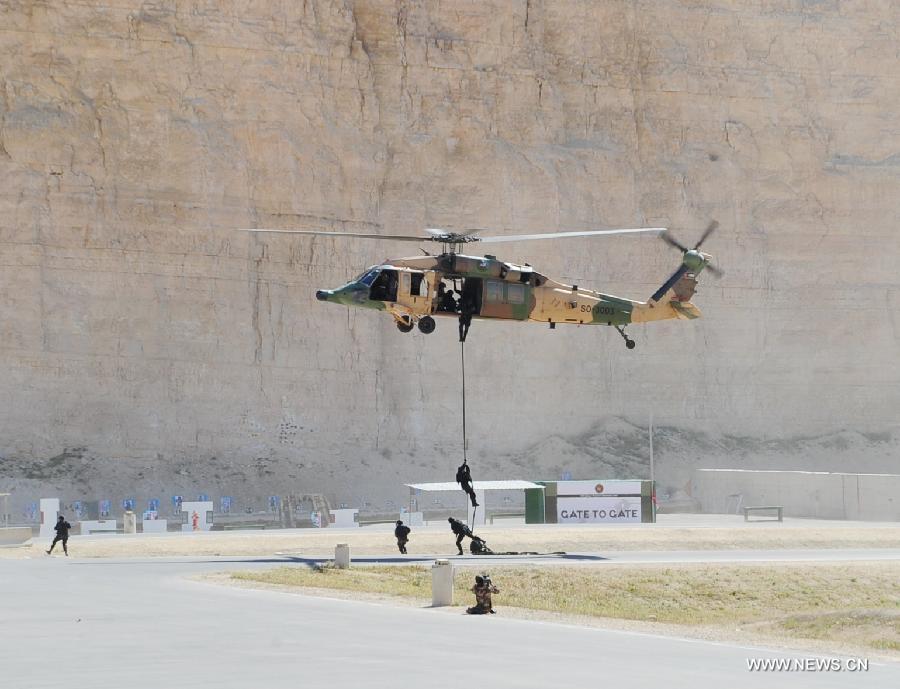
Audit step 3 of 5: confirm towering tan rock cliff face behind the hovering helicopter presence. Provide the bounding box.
[0,0,900,504]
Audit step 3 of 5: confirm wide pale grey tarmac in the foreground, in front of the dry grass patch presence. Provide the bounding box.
[0,553,900,689]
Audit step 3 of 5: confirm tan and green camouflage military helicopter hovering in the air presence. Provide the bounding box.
[244,221,722,349]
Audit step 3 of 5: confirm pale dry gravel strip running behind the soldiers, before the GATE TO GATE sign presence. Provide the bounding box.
[7,520,900,558]
